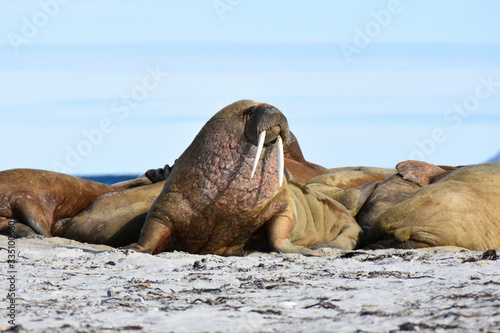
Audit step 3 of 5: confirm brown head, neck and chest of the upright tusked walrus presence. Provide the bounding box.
[136,100,291,255]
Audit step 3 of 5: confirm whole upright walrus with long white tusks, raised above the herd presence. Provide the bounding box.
[127,100,361,256]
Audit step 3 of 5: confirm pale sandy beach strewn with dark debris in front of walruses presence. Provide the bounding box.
[0,236,500,332]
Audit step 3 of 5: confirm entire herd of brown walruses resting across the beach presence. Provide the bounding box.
[0,100,500,256]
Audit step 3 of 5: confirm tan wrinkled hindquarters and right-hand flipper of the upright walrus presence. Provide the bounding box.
[245,181,362,256]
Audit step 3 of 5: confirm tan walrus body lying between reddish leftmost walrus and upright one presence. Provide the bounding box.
[54,181,165,247]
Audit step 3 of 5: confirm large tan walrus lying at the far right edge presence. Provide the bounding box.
[365,162,500,251]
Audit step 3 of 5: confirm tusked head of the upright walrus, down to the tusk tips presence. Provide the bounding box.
[174,100,292,186]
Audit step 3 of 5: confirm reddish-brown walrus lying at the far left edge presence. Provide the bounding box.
[0,169,124,237]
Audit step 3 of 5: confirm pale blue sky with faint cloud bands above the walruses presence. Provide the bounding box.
[0,0,500,175]
